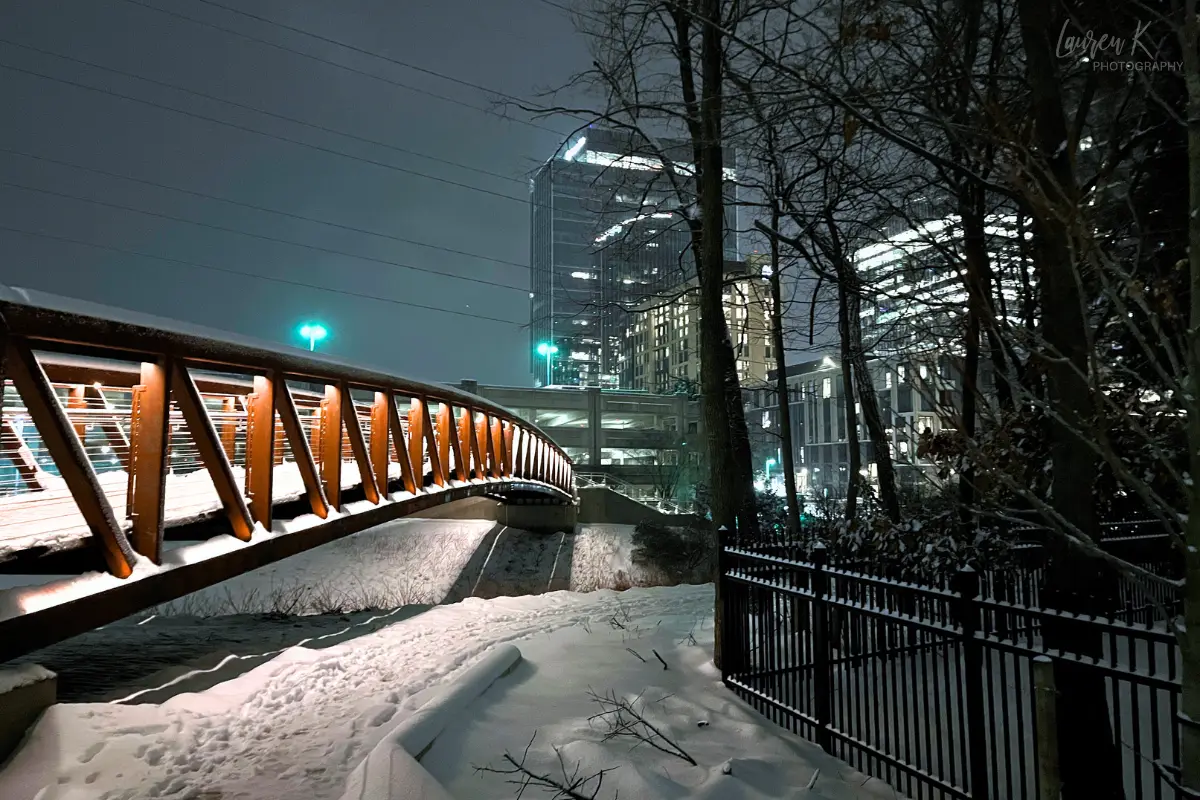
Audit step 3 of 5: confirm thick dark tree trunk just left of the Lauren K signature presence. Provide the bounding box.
[1018,0,1123,800]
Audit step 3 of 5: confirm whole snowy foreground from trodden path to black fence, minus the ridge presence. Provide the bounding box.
[0,587,893,800]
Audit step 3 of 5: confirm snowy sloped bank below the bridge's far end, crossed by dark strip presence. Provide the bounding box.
[136,517,696,616]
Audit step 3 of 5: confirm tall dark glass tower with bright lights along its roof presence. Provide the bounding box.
[529,127,738,387]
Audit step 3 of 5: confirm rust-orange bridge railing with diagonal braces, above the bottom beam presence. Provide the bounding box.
[0,287,574,577]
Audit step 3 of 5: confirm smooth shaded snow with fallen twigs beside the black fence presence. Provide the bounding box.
[421,587,895,800]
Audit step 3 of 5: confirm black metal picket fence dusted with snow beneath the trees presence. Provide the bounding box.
[721,543,1180,800]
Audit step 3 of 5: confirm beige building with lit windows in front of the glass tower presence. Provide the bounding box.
[620,257,774,392]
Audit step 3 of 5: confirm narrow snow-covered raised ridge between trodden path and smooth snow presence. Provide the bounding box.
[342,644,521,800]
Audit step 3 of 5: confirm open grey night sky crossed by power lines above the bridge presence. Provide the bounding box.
[0,0,588,385]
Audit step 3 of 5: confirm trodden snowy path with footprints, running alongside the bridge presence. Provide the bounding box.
[0,587,712,800]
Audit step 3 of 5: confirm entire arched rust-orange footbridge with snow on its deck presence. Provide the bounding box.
[0,287,575,661]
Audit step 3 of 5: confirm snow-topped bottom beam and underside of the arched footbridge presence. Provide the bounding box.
[0,480,575,662]
